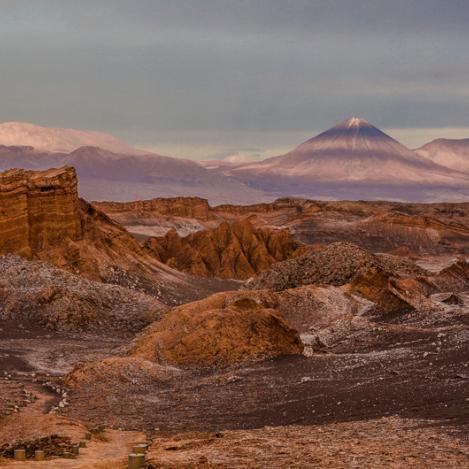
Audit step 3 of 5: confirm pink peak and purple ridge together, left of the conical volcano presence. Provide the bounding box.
[0,123,272,203]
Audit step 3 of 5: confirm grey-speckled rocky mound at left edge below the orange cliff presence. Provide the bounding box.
[0,255,167,333]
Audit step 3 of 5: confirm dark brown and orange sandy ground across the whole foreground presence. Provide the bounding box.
[0,288,469,469]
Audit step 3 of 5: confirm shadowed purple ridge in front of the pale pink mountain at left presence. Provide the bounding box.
[0,146,272,204]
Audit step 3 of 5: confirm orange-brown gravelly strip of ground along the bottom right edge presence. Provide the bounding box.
[148,417,469,469]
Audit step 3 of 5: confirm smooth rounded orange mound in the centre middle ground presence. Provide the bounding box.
[131,294,303,367]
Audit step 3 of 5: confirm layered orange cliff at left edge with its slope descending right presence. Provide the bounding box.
[0,167,234,303]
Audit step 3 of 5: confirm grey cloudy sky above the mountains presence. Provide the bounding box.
[0,0,469,159]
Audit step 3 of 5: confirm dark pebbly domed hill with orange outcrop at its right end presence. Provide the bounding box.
[247,243,436,317]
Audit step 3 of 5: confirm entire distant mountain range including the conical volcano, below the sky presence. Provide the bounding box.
[0,117,469,204]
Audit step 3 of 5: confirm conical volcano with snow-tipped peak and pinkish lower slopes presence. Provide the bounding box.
[224,117,469,200]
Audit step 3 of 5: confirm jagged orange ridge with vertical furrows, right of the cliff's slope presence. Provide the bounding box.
[145,219,302,279]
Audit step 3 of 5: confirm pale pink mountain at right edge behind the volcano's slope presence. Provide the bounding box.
[415,138,469,173]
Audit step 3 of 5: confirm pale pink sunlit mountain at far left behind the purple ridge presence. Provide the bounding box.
[0,122,147,155]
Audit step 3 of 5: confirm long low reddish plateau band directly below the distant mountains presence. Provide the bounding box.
[96,198,469,255]
